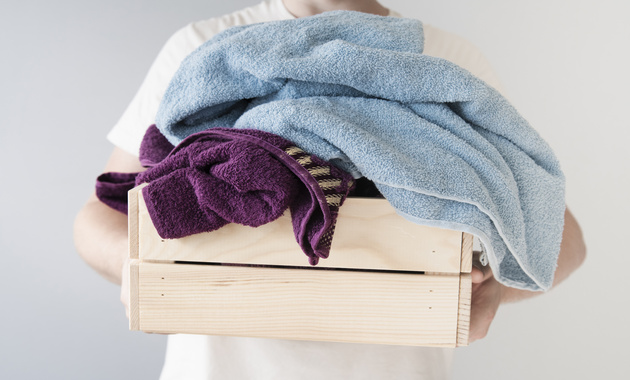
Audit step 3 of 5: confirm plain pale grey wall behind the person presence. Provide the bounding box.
[0,0,630,379]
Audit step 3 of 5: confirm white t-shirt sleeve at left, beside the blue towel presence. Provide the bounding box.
[107,24,203,156]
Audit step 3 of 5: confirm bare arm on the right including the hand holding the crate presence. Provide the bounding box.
[469,208,586,342]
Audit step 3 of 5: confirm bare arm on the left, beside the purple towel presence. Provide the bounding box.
[74,148,145,284]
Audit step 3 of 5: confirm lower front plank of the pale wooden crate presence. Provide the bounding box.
[139,262,460,347]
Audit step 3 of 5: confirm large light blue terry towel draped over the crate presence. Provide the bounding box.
[156,11,565,290]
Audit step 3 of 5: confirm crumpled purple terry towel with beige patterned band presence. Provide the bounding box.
[97,126,354,265]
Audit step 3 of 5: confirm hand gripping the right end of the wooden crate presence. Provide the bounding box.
[468,264,503,343]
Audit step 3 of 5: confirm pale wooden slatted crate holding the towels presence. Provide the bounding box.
[129,184,472,347]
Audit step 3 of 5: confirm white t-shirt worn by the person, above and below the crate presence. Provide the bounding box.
[107,0,500,380]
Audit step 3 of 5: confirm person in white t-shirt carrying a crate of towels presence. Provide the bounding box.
[74,0,586,379]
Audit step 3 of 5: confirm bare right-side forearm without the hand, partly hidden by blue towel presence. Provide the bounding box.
[501,208,586,303]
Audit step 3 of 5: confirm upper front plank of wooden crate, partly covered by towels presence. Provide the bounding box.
[138,189,462,273]
